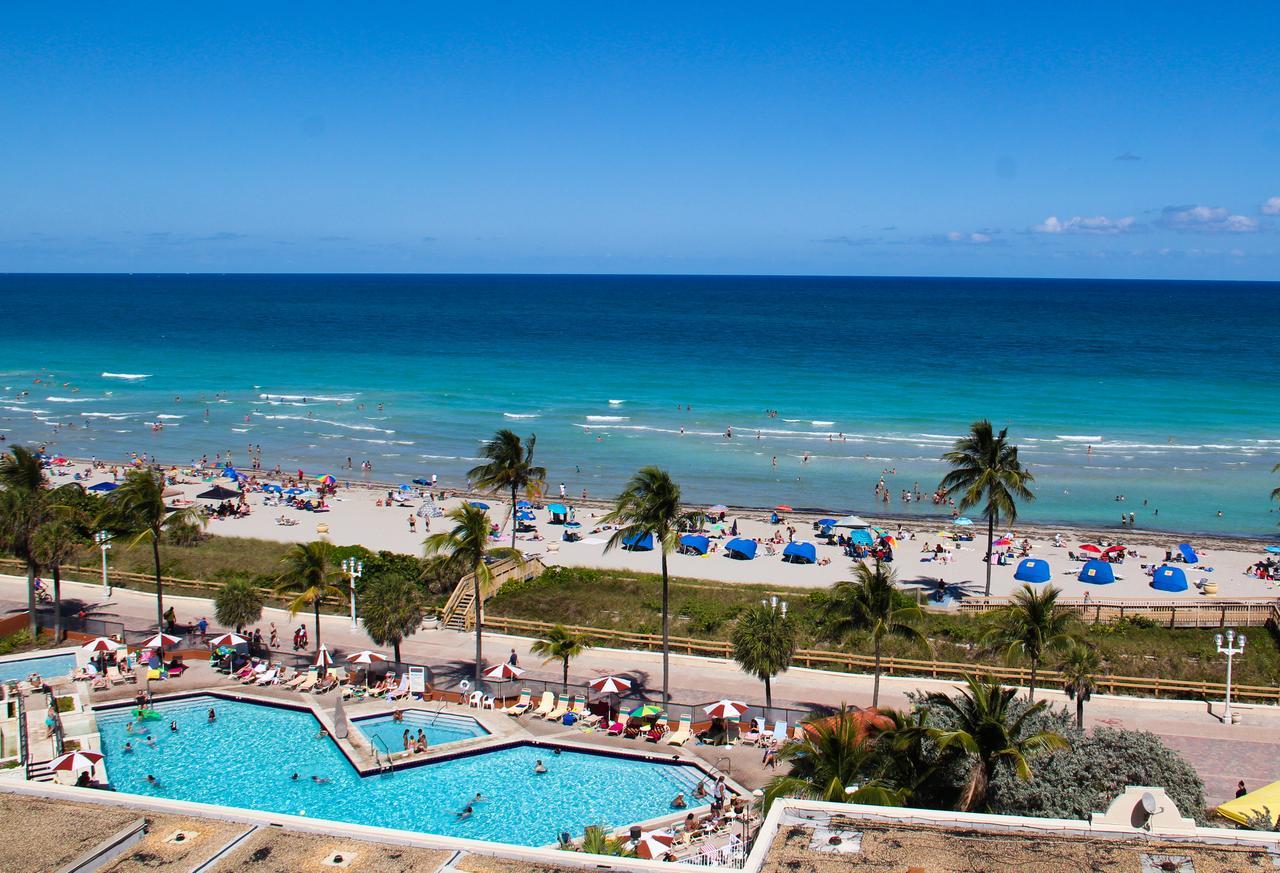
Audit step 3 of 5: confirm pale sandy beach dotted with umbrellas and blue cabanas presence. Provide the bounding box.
[55,465,1280,602]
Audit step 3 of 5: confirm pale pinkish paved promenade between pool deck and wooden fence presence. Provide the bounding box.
[0,576,1280,805]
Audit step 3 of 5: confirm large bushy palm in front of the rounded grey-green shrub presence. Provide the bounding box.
[928,676,1068,812]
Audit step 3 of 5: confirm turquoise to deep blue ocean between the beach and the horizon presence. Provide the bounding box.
[0,275,1280,534]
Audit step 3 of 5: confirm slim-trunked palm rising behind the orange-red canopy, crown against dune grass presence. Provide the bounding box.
[822,561,928,707]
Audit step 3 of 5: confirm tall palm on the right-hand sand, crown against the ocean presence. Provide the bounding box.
[938,419,1036,597]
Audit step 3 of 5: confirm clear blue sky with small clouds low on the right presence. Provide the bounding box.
[0,3,1280,279]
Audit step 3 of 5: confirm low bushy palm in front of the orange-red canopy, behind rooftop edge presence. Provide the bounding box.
[764,707,905,806]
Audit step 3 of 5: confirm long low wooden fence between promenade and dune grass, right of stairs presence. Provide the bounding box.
[484,613,1280,703]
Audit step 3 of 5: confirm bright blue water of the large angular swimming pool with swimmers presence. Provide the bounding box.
[97,695,701,846]
